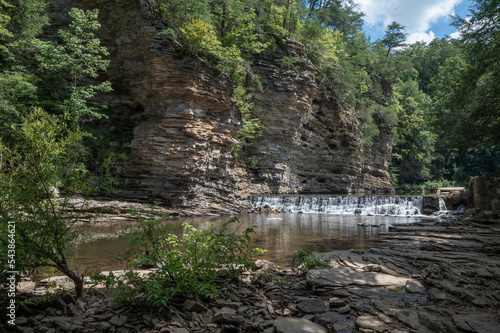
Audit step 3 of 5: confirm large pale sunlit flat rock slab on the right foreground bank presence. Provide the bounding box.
[307,266,414,287]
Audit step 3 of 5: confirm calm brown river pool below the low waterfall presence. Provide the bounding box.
[69,213,426,272]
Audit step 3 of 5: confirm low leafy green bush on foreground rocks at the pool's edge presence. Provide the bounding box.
[97,203,263,311]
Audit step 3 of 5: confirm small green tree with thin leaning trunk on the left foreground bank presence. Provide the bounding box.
[0,109,89,296]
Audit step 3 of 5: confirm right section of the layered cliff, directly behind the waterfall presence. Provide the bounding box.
[246,40,393,193]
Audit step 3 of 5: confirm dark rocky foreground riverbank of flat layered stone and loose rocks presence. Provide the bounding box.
[10,214,500,333]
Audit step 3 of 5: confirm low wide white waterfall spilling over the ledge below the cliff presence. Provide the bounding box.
[250,195,423,216]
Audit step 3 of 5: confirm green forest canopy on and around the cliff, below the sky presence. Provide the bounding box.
[0,0,500,184]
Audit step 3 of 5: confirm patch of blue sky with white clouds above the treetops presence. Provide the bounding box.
[354,0,470,44]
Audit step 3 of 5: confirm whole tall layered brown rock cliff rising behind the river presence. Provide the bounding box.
[47,0,392,212]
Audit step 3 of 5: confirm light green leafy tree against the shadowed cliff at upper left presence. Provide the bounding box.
[39,8,112,125]
